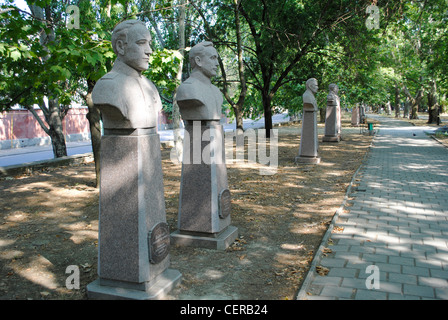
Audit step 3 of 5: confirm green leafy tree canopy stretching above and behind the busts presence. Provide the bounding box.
[0,0,448,147]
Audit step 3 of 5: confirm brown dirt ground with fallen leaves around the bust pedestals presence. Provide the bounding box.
[0,116,373,300]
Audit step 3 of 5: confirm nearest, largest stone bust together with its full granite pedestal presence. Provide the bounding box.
[87,20,181,300]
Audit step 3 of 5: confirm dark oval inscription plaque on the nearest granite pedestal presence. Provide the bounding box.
[148,222,170,264]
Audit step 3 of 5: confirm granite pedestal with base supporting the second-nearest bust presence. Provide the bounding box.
[171,121,238,250]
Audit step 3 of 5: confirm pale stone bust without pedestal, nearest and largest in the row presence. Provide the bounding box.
[92,20,162,129]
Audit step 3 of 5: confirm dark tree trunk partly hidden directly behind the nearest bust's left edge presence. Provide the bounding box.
[84,80,101,187]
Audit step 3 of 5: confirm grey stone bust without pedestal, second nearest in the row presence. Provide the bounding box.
[176,41,223,120]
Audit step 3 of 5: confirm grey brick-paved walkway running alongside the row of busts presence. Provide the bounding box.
[297,117,448,300]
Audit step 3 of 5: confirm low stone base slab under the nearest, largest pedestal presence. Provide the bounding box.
[87,269,182,300]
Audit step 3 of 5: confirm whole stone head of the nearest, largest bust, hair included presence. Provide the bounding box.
[112,20,152,72]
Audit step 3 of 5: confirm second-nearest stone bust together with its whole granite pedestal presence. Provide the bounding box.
[171,41,238,250]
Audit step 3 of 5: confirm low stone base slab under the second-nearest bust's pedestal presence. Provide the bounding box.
[171,226,238,250]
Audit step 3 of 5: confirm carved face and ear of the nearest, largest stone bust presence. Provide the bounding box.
[117,24,152,71]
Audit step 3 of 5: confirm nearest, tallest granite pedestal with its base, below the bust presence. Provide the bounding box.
[87,128,181,299]
